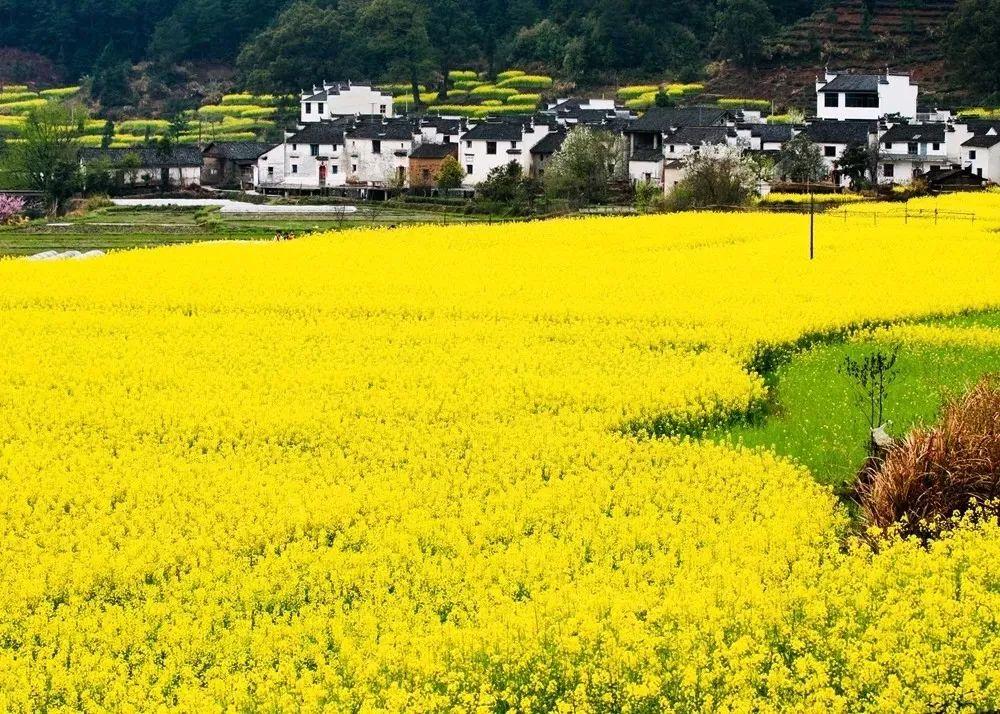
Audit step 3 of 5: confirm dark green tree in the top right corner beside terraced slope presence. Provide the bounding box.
[945,0,1000,95]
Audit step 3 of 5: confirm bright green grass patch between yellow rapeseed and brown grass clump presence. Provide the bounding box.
[708,311,1000,492]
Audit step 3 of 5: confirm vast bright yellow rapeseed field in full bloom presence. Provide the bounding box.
[0,207,1000,712]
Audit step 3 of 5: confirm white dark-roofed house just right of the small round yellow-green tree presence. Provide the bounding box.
[458,117,550,186]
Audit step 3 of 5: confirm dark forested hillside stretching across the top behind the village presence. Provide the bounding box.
[0,0,1000,103]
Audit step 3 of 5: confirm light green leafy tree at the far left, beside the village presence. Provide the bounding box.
[3,104,80,215]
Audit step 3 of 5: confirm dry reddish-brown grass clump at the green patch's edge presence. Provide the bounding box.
[857,376,1000,536]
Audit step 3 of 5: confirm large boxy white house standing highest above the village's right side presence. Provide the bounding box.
[816,71,918,121]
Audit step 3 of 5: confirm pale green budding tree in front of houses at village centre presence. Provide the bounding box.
[543,127,628,203]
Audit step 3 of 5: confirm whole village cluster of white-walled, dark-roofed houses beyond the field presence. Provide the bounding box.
[83,71,1000,198]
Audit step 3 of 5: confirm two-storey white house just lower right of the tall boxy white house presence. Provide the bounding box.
[878,123,954,184]
